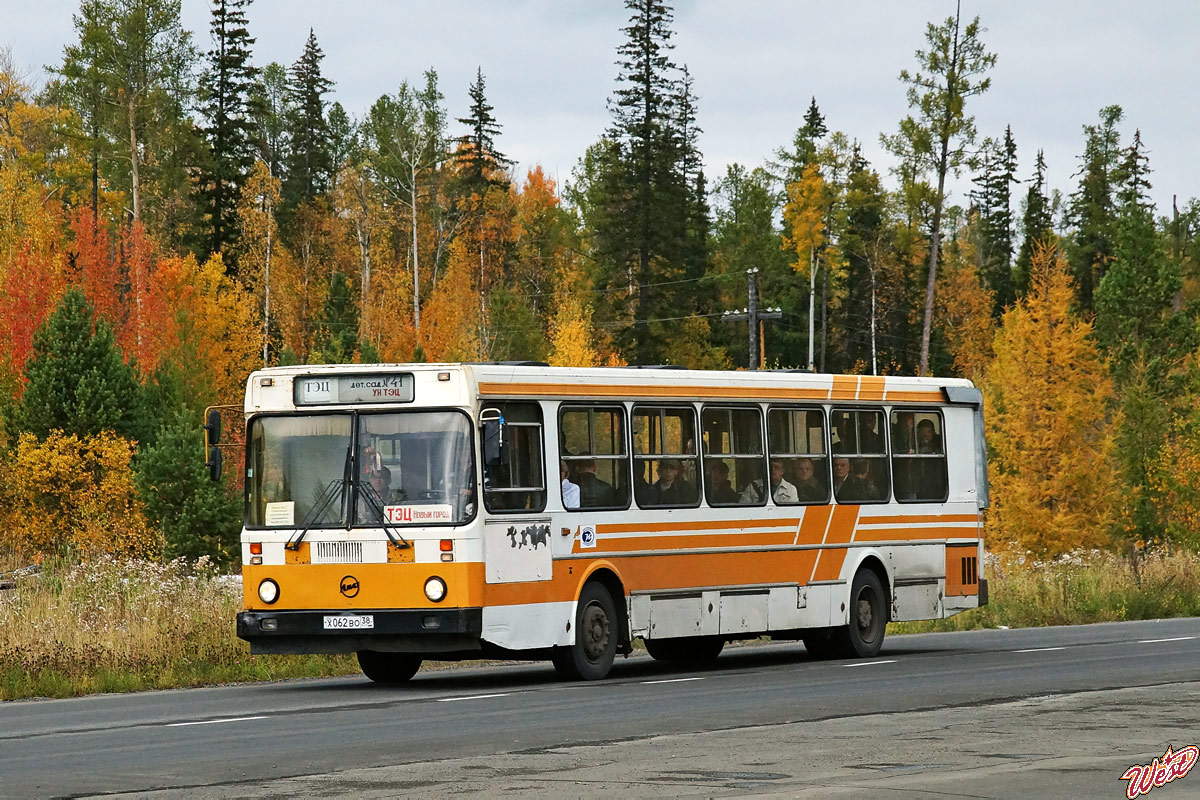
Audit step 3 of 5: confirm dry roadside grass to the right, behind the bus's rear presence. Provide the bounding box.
[892,549,1200,633]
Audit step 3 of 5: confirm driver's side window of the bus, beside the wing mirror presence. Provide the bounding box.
[480,403,546,513]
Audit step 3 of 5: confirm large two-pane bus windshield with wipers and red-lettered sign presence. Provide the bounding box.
[246,411,475,528]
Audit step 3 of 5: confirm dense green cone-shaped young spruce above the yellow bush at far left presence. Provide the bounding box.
[12,287,145,439]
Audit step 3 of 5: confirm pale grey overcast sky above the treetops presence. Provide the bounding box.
[0,0,1200,213]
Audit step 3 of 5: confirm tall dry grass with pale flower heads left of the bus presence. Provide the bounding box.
[0,559,358,699]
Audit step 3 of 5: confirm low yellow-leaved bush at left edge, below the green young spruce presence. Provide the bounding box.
[0,431,163,559]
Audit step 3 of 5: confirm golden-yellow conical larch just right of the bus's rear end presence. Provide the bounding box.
[984,247,1118,557]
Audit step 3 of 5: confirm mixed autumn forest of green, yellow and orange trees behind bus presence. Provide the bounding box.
[0,0,1200,565]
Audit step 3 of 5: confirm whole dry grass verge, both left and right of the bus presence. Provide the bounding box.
[0,551,1200,700]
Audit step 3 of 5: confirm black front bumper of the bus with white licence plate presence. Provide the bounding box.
[238,608,484,655]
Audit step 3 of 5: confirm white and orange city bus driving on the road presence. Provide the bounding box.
[223,362,988,684]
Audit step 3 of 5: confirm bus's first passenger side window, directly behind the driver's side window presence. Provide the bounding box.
[558,404,629,511]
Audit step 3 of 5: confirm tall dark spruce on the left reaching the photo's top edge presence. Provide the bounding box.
[199,0,258,263]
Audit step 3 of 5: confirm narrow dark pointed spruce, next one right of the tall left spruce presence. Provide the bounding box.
[283,28,334,207]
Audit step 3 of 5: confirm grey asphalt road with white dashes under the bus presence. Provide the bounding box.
[0,619,1200,800]
